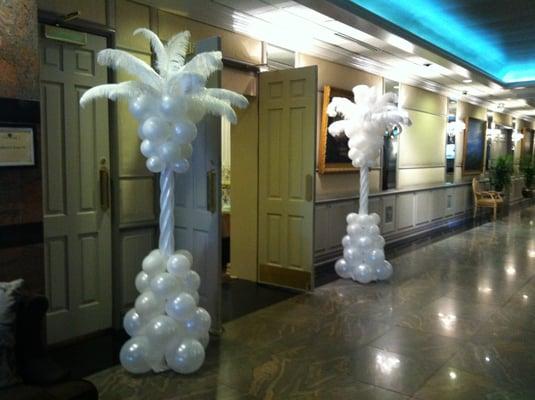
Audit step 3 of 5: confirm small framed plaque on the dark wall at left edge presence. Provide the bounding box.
[0,127,35,167]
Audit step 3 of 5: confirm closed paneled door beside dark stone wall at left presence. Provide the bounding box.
[39,30,112,343]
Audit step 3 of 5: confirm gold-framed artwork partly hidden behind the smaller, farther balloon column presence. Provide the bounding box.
[318,85,356,174]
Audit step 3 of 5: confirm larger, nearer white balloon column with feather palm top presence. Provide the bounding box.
[80,29,247,374]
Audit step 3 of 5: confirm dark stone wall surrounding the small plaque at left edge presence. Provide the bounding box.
[0,0,45,293]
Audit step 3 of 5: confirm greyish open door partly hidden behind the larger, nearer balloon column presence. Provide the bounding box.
[175,37,221,334]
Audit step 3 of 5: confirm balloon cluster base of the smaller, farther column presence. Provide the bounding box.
[334,213,392,283]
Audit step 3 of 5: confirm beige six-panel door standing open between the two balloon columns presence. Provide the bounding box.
[258,66,318,290]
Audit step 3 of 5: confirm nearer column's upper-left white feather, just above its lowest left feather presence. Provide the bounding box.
[97,49,162,89]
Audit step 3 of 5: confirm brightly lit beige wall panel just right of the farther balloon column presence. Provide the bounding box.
[397,84,448,188]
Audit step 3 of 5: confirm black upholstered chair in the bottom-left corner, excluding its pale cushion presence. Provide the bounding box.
[0,295,98,400]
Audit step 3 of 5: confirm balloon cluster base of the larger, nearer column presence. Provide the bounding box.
[120,249,211,374]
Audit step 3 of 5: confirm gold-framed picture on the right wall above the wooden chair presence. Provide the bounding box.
[463,117,487,175]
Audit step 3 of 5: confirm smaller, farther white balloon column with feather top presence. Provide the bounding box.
[327,85,411,283]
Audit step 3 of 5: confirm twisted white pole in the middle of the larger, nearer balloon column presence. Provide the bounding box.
[159,165,175,257]
